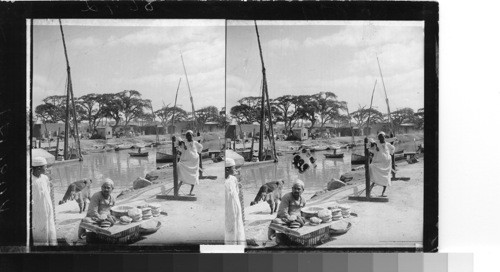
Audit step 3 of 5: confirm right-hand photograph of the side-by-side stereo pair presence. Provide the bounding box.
[224,21,424,249]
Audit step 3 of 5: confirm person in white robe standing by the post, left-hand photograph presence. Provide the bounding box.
[177,130,203,196]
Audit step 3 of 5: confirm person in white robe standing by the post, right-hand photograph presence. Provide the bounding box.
[370,131,396,197]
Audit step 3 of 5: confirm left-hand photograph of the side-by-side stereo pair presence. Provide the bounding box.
[27,19,226,248]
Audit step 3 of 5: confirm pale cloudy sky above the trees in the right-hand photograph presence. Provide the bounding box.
[226,21,424,113]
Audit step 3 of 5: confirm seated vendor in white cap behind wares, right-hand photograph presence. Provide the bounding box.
[278,179,306,219]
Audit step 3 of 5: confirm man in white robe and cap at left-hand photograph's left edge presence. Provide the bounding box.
[31,157,57,246]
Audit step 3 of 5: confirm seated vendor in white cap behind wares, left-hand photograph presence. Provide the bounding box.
[87,178,115,218]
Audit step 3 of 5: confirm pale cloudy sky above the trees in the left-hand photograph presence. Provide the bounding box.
[32,20,225,115]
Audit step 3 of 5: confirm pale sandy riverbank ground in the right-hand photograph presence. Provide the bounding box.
[245,156,424,248]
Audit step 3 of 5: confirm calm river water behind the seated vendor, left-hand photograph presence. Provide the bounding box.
[50,148,170,190]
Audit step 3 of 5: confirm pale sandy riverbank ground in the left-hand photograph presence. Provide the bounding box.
[55,159,224,245]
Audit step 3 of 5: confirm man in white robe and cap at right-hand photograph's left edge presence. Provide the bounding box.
[224,158,246,246]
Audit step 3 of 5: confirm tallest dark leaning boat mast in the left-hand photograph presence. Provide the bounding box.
[59,19,82,160]
